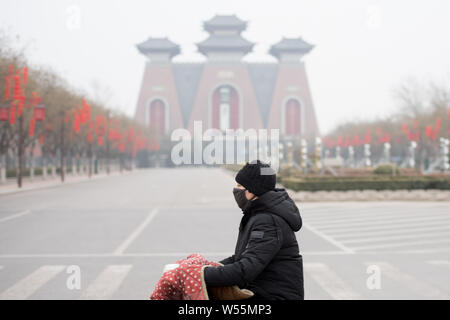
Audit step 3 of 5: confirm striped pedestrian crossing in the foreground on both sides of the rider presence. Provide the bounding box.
[0,260,450,300]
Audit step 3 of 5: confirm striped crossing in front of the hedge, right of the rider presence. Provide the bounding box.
[299,202,450,253]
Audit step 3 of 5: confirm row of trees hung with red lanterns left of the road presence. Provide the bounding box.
[0,37,159,187]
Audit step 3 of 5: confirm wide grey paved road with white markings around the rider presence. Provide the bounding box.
[0,168,450,299]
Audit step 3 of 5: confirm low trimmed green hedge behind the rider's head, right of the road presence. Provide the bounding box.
[280,177,450,191]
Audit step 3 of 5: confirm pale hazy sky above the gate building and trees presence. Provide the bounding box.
[0,0,450,133]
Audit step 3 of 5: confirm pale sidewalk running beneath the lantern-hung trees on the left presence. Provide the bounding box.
[0,169,138,195]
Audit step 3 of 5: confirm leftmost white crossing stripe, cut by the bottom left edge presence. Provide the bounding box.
[0,265,65,300]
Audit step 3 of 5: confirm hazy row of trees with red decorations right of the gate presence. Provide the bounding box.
[323,80,450,169]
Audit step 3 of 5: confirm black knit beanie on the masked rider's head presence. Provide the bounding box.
[235,160,276,196]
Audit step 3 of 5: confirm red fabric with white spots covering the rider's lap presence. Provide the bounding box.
[150,253,221,300]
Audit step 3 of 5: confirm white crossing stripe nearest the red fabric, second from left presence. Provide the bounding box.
[80,265,133,300]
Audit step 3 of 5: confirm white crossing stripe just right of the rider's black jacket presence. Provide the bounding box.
[304,263,361,300]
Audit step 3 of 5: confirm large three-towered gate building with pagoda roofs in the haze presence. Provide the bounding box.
[135,15,319,138]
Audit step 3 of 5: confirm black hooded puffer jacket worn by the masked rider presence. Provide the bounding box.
[205,189,304,300]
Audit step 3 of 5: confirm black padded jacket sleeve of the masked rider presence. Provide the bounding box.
[204,216,282,287]
